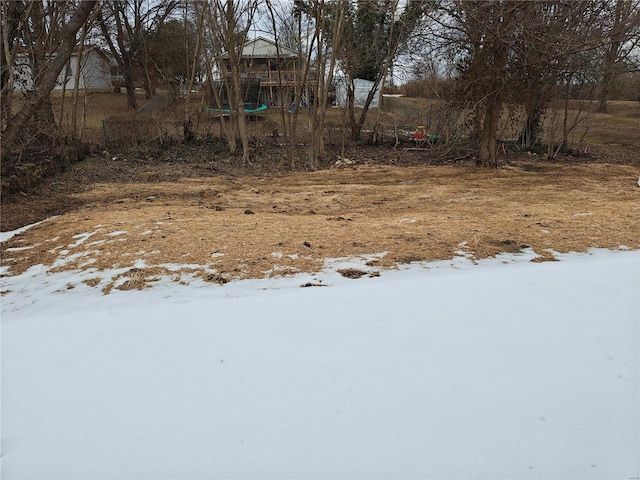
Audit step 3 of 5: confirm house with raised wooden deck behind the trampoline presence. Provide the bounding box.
[218,37,310,106]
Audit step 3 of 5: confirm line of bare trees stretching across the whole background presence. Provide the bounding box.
[0,0,640,168]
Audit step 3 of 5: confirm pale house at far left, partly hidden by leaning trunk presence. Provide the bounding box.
[13,45,112,91]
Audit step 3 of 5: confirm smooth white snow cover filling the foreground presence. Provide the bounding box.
[1,220,640,480]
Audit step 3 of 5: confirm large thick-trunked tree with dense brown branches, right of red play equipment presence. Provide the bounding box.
[424,0,607,166]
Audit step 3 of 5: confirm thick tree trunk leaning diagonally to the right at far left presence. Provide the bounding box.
[2,0,98,158]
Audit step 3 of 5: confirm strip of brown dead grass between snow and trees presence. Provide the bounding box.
[2,142,640,290]
